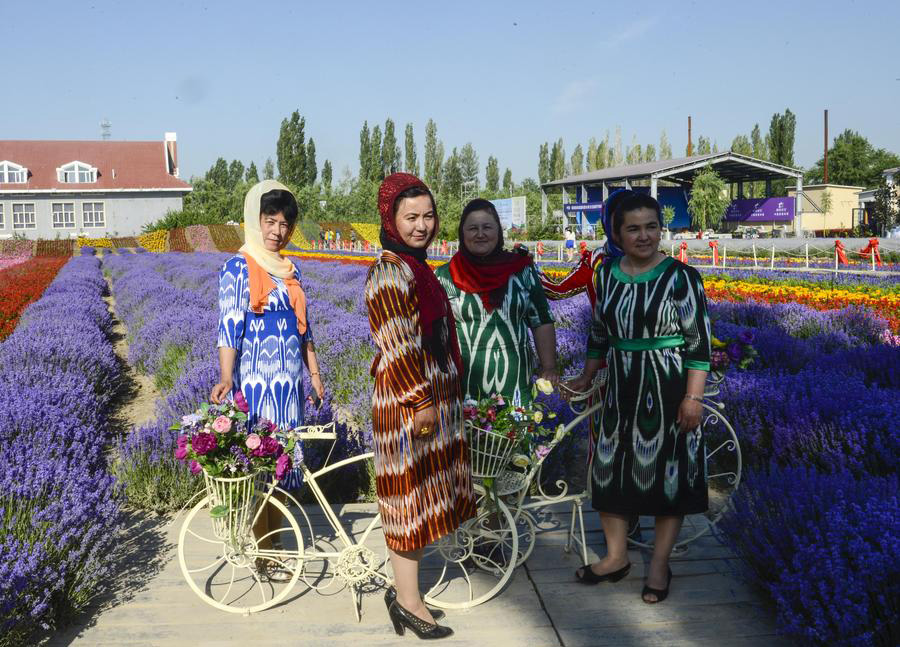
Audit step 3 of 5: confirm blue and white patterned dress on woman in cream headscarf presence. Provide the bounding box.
[217,255,312,488]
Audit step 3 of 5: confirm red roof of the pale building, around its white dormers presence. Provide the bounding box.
[0,140,191,192]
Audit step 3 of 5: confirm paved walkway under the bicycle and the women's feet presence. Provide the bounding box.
[48,505,787,647]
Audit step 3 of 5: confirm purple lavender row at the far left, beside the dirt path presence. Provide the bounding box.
[0,256,120,645]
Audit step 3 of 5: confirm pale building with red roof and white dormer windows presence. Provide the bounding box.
[0,133,191,239]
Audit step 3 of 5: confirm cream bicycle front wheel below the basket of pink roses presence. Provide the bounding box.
[178,496,303,614]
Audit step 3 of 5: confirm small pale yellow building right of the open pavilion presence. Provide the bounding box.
[788,184,864,236]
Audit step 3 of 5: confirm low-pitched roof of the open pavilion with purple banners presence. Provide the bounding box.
[541,151,803,233]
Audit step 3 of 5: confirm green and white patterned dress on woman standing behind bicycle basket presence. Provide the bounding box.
[435,263,553,406]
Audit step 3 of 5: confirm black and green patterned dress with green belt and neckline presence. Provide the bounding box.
[588,258,711,515]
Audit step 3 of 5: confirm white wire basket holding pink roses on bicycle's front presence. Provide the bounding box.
[203,470,271,543]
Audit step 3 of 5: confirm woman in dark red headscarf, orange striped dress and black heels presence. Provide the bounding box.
[365,173,475,639]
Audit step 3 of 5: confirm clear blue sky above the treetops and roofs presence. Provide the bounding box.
[0,0,900,181]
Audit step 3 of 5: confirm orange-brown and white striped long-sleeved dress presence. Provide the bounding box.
[366,251,475,552]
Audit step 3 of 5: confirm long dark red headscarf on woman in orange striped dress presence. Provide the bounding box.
[378,173,462,375]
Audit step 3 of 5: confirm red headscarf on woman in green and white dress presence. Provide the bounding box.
[450,198,532,312]
